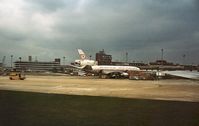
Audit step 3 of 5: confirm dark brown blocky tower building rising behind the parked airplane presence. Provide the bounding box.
[96,50,112,65]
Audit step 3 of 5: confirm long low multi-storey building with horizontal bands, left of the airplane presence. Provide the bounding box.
[14,56,60,72]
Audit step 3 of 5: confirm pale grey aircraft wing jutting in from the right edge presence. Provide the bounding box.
[163,71,199,80]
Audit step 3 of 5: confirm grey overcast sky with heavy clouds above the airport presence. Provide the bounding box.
[0,0,199,64]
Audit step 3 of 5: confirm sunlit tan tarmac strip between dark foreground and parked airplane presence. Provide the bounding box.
[0,75,199,102]
